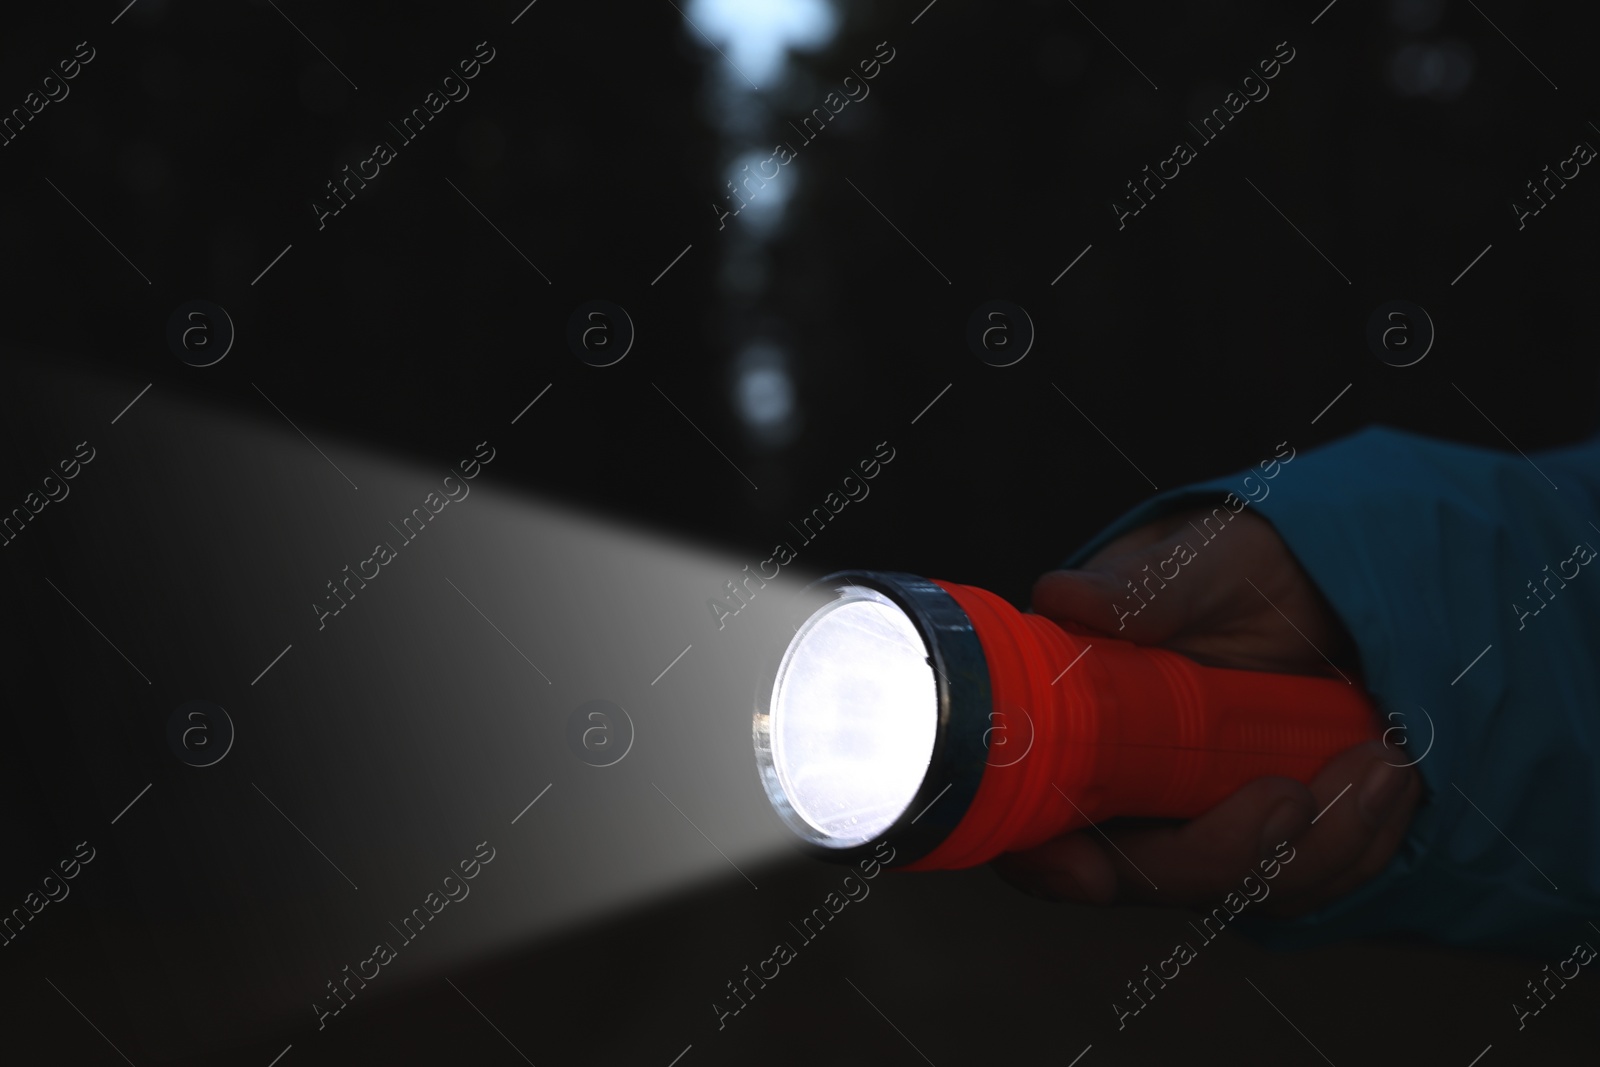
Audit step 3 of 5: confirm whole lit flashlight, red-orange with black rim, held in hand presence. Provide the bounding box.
[754,571,1378,870]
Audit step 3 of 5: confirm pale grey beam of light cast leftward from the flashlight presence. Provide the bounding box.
[10,361,811,1062]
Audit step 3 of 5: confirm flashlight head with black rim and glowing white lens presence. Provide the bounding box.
[754,571,989,865]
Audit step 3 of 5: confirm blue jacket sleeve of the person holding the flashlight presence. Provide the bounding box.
[1066,429,1600,952]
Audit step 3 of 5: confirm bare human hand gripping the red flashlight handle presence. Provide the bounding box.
[994,509,1422,917]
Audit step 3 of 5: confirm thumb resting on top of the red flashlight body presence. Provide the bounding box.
[1032,539,1195,645]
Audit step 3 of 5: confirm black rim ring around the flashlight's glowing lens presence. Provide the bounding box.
[754,571,990,867]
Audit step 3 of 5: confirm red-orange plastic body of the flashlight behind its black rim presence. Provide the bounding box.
[906,581,1379,870]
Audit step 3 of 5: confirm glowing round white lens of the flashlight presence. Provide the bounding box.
[771,585,939,848]
